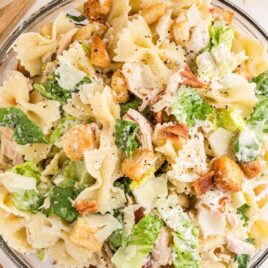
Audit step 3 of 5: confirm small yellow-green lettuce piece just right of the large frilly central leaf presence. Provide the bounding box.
[217,108,246,131]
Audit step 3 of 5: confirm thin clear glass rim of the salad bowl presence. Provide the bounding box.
[0,0,268,268]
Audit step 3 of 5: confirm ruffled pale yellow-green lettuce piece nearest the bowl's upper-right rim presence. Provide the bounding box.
[209,21,234,50]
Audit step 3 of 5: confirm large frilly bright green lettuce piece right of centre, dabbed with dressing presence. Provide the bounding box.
[171,86,213,126]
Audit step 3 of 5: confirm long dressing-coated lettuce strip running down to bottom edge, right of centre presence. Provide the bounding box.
[156,195,199,268]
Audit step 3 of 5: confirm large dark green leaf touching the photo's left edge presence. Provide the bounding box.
[0,107,47,145]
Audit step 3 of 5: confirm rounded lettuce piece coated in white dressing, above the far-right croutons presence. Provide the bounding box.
[234,129,261,163]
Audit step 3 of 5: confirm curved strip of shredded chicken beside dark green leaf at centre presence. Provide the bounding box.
[127,109,153,151]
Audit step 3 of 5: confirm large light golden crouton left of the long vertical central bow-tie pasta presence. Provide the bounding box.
[62,124,99,161]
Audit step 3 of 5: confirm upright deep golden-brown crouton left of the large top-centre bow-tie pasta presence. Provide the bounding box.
[91,36,111,68]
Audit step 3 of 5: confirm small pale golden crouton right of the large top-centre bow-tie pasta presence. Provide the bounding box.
[172,20,191,46]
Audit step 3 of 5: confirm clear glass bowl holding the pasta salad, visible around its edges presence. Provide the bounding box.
[0,0,268,268]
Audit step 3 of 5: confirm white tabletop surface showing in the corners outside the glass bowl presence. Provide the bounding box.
[0,0,268,268]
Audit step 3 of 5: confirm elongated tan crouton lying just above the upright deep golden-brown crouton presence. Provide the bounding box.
[74,21,107,41]
